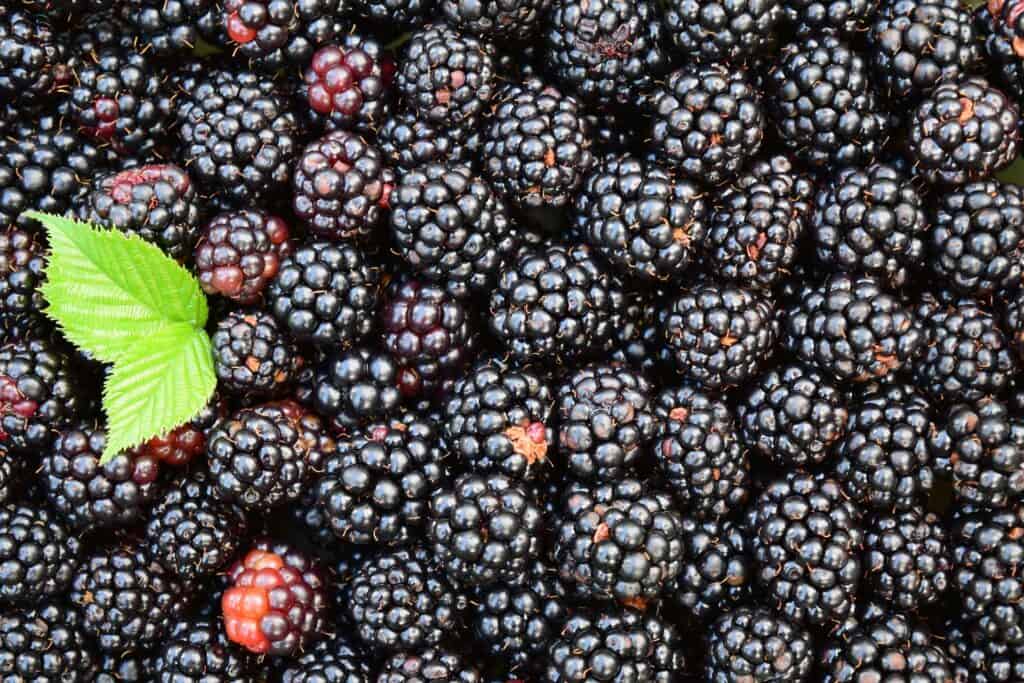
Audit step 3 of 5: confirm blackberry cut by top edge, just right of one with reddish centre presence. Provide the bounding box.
[665,0,783,62]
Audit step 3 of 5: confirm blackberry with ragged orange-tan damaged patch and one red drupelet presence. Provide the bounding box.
[443,358,555,480]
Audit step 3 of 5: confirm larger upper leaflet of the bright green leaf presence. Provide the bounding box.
[26,211,207,362]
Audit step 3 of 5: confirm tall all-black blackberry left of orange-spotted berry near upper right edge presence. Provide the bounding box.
[768,35,889,167]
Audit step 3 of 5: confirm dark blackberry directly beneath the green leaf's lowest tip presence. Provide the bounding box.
[40,425,164,530]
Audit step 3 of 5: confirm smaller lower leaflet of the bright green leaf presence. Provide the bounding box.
[100,324,217,463]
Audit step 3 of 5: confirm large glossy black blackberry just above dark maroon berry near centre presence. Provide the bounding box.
[389,164,520,299]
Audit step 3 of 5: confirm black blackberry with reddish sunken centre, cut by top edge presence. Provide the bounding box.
[544,0,671,105]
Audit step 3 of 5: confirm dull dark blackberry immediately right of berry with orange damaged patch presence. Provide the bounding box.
[558,364,658,481]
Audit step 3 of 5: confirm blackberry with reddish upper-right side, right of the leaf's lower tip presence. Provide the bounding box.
[207,400,336,510]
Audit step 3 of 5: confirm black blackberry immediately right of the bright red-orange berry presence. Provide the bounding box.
[345,547,469,652]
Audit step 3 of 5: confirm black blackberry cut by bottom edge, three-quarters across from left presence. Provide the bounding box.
[706,607,815,683]
